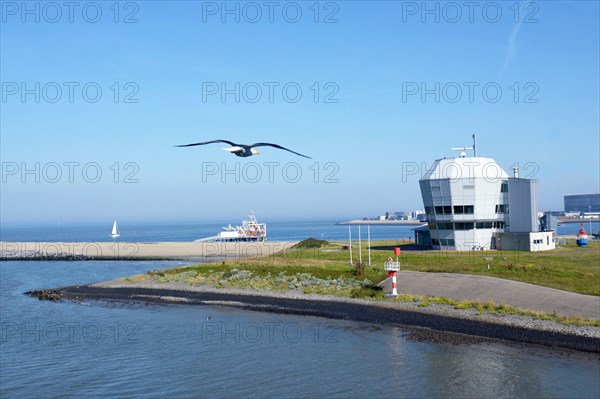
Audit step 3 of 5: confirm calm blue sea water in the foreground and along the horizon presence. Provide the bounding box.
[0,223,600,398]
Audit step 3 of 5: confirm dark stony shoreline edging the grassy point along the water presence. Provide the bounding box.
[26,281,600,353]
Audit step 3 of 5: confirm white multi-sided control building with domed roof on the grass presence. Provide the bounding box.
[415,147,555,251]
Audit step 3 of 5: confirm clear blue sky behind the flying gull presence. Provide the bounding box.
[0,1,600,224]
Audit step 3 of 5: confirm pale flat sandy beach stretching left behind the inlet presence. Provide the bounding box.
[0,242,296,261]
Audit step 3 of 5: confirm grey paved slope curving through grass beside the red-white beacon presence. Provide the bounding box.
[381,271,600,319]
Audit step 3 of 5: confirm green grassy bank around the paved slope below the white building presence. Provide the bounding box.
[118,241,600,326]
